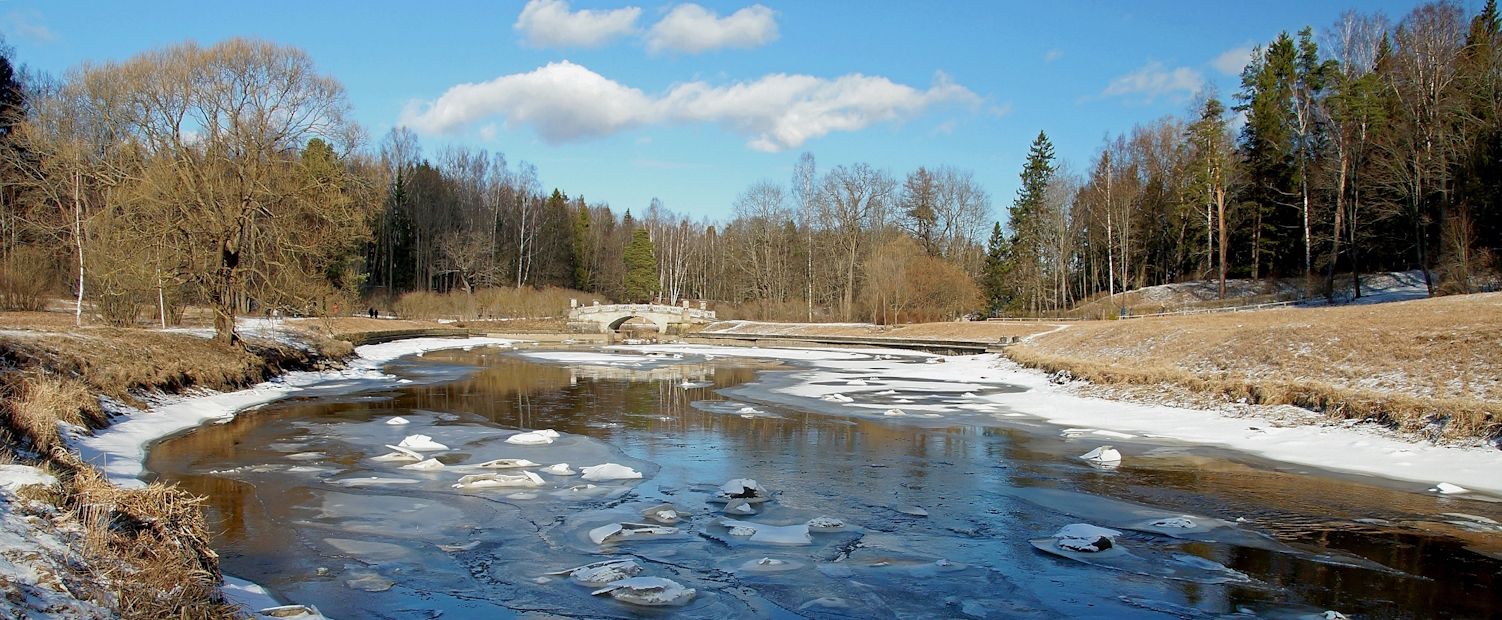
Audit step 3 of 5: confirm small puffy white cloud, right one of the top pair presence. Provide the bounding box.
[646,3,778,54]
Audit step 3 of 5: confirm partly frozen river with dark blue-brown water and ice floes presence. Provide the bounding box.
[147,348,1502,620]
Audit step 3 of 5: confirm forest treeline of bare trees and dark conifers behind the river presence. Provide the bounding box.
[0,2,1502,339]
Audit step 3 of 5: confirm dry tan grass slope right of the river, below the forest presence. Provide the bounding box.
[1008,293,1502,438]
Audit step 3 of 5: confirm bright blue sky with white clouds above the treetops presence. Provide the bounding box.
[0,0,1429,219]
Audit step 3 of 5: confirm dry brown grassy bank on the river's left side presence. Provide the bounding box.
[0,312,351,618]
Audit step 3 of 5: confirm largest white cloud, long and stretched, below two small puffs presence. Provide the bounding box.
[403,60,981,152]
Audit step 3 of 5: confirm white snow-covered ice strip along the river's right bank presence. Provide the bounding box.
[615,345,1502,495]
